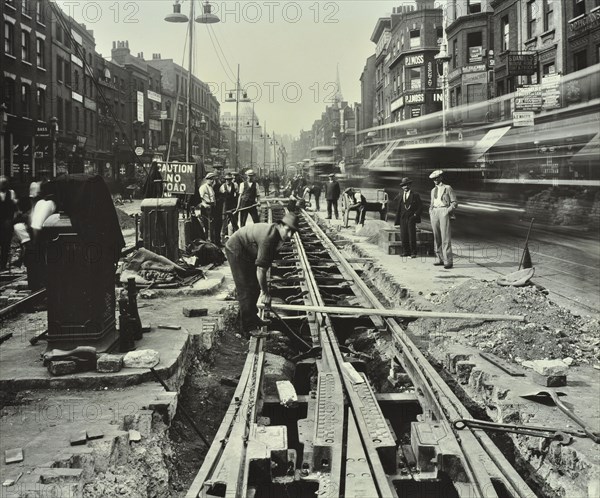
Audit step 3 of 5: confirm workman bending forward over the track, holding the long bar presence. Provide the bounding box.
[225,213,298,337]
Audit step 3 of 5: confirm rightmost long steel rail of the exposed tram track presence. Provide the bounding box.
[304,212,535,498]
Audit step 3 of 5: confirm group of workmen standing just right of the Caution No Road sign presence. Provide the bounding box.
[198,170,259,247]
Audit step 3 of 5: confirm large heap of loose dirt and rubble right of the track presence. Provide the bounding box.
[418,280,600,364]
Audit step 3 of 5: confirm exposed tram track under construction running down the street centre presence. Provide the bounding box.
[187,204,535,498]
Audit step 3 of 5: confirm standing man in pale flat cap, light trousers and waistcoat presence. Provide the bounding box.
[429,169,458,270]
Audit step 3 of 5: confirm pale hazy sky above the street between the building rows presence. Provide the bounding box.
[59,0,413,135]
